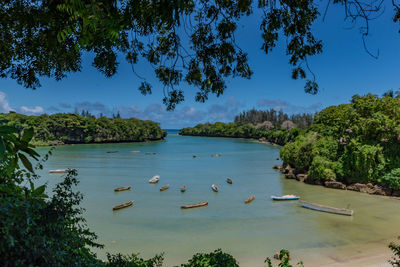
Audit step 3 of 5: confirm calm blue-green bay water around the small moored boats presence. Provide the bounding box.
[36,132,400,266]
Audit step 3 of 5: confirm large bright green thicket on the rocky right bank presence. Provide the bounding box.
[281,94,400,190]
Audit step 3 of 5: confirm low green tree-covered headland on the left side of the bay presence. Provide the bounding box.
[0,112,165,145]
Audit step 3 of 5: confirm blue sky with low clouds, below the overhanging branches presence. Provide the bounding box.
[0,1,400,129]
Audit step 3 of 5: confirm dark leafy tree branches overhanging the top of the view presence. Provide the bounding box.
[0,0,400,109]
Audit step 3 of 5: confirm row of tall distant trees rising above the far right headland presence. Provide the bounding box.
[235,109,314,129]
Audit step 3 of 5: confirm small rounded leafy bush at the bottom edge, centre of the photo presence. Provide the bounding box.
[181,249,239,267]
